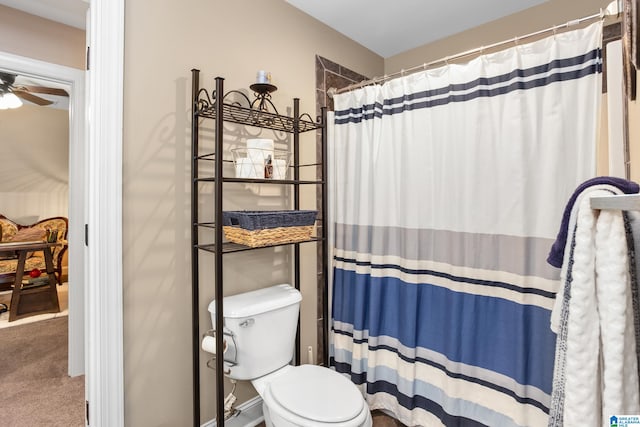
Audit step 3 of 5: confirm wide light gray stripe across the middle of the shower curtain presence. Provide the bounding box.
[335,224,560,280]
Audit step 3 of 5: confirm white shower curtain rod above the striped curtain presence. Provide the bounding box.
[336,5,621,97]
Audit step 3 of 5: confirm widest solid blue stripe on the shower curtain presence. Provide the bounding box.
[333,269,555,398]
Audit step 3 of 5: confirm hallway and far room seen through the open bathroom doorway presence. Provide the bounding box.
[0,5,86,425]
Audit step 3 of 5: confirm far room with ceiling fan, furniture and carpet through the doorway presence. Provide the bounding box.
[0,72,84,424]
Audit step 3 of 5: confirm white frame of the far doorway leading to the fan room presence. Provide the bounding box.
[0,52,86,377]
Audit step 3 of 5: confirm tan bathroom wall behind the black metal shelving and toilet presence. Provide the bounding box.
[123,0,384,427]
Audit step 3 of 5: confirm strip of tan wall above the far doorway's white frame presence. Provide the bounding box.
[0,5,85,69]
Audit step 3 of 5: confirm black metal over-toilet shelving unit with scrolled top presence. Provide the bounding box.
[191,69,328,427]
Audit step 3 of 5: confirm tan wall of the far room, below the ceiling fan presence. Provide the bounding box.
[0,105,69,224]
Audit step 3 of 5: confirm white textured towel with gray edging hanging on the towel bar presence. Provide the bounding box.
[549,188,640,427]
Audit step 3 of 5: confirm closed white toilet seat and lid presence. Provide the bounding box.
[263,365,369,427]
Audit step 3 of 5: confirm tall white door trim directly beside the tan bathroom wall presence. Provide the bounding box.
[85,0,124,427]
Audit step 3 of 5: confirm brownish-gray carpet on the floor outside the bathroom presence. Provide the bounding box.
[0,316,85,427]
